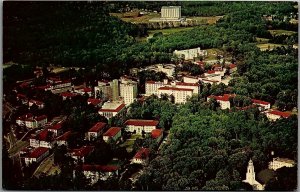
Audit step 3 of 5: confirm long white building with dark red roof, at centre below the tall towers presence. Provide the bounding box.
[125,119,159,134]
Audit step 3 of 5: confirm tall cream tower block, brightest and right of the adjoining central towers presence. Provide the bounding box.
[120,81,137,105]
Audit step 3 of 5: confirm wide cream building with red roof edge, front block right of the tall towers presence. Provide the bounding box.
[158,87,193,104]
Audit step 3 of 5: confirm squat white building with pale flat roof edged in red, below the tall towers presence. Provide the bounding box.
[98,102,126,119]
